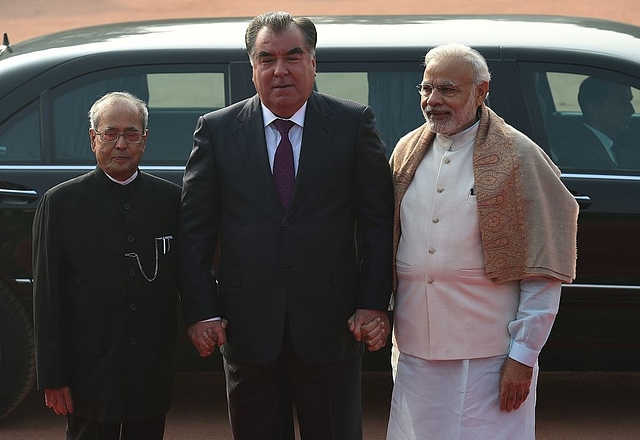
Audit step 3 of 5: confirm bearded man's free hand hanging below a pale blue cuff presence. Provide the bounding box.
[498,357,533,412]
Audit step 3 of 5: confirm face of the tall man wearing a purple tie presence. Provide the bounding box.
[252,26,316,118]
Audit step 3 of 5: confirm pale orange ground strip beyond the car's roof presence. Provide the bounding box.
[5,0,640,43]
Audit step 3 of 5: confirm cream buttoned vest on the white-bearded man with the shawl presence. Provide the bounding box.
[394,124,520,360]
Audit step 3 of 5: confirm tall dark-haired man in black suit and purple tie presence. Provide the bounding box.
[180,12,393,440]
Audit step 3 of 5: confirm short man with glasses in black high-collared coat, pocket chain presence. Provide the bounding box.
[33,92,180,440]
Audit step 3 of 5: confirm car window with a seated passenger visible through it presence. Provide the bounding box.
[534,71,640,173]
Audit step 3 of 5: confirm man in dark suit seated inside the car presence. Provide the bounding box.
[558,77,640,170]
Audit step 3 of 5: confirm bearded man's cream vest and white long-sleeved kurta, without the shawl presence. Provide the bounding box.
[387,125,560,440]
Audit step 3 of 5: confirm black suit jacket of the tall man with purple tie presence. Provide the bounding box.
[180,92,393,364]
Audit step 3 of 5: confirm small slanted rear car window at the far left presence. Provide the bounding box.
[0,101,42,163]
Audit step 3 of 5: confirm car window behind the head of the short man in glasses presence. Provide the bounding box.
[51,69,227,165]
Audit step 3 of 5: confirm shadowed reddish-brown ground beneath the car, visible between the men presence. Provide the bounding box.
[0,372,640,440]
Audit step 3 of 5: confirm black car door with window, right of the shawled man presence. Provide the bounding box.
[518,61,640,370]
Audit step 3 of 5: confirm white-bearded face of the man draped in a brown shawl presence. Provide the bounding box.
[420,58,489,135]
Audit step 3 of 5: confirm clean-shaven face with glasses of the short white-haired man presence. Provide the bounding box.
[89,101,147,181]
